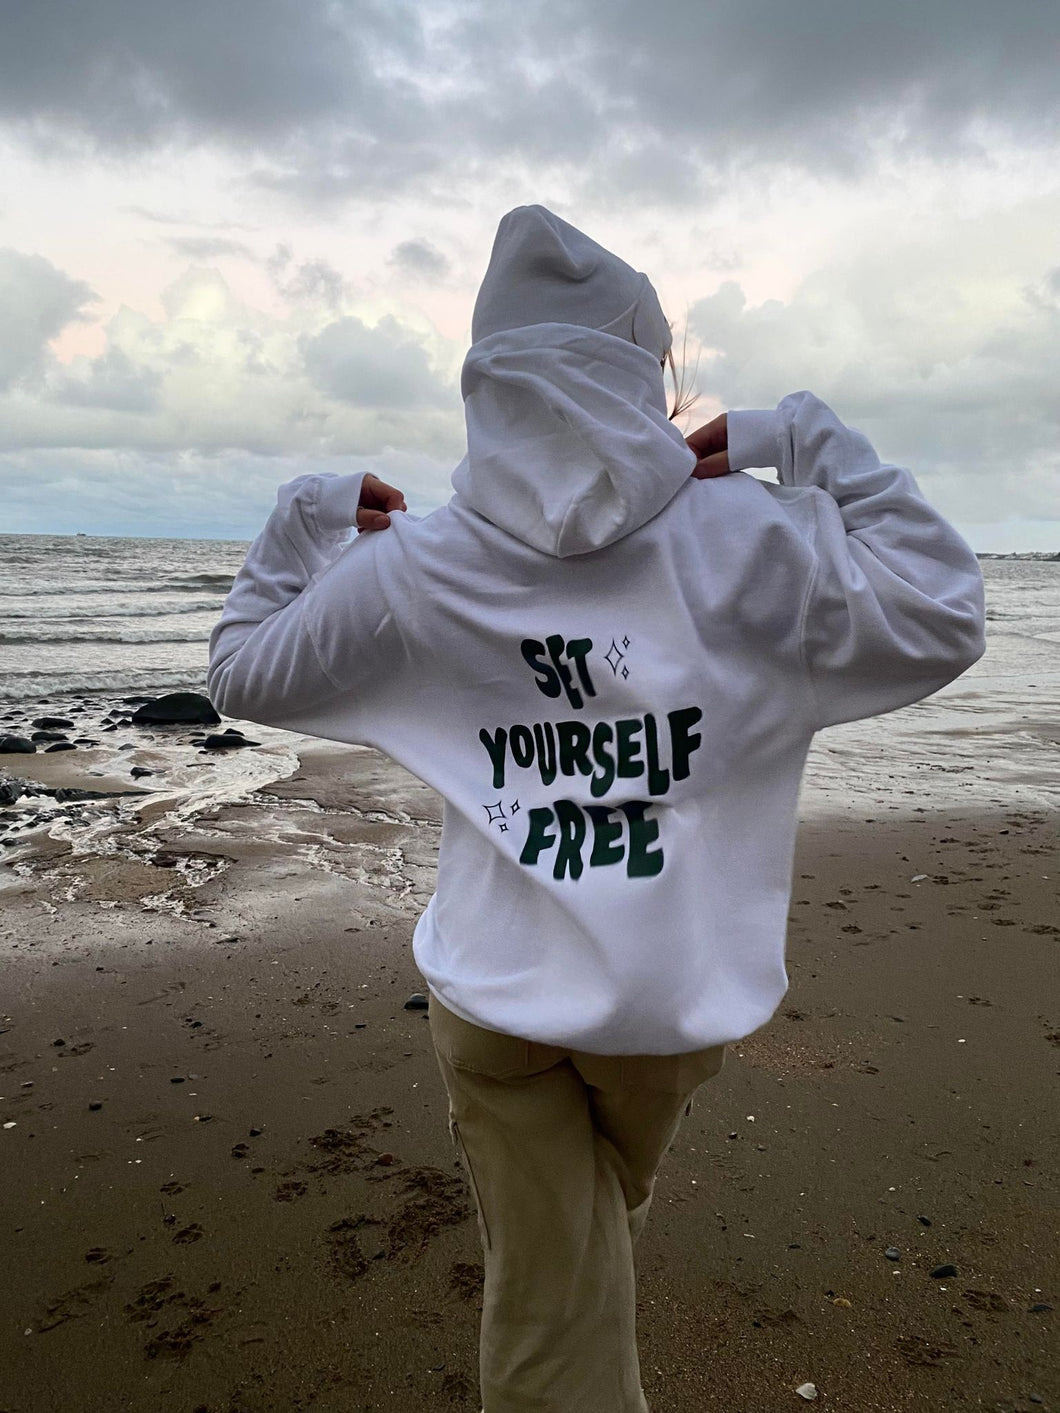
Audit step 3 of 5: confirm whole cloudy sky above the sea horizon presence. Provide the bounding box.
[0,0,1060,550]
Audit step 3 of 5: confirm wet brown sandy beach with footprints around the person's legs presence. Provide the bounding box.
[0,707,1060,1413]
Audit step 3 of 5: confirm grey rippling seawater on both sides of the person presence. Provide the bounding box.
[0,536,1060,814]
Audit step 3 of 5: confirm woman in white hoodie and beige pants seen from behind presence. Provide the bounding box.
[209,206,984,1413]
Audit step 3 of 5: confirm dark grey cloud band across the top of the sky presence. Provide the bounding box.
[0,0,1060,202]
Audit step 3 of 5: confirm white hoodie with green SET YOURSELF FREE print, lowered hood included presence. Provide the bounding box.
[208,324,984,1054]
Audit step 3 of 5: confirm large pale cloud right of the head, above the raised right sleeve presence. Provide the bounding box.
[688,257,1060,520]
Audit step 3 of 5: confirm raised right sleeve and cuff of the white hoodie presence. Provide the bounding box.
[728,393,985,729]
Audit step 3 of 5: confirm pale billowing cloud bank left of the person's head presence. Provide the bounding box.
[0,252,464,462]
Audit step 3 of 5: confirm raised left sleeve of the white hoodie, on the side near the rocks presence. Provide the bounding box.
[206,475,387,726]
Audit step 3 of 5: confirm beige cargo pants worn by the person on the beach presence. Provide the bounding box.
[430,993,725,1413]
